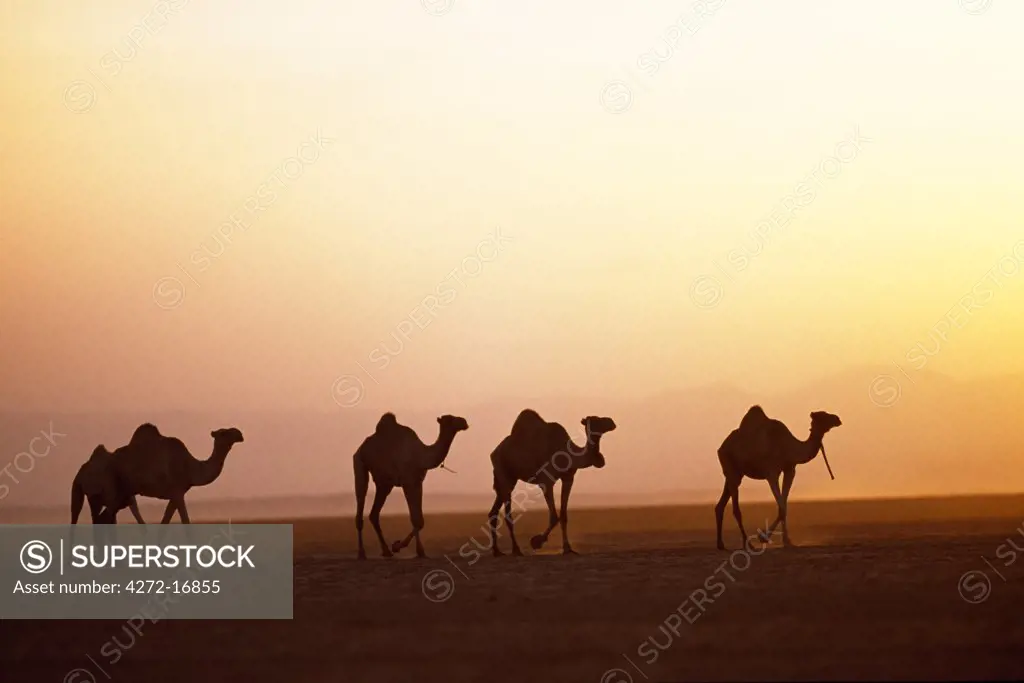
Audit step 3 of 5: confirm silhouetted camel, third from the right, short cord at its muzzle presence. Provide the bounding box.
[352,413,469,560]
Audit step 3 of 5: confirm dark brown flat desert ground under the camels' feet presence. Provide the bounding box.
[0,497,1024,683]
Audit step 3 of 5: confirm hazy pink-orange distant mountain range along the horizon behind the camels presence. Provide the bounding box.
[0,366,1024,516]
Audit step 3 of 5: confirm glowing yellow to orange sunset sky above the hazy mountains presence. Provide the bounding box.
[0,0,1024,417]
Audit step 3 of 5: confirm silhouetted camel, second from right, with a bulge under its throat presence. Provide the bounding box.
[487,409,615,557]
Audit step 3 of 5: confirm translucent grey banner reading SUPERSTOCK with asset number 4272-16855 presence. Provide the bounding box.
[0,523,293,622]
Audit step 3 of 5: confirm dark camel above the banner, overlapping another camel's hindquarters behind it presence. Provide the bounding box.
[111,423,245,524]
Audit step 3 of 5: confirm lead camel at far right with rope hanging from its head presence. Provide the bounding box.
[715,405,843,550]
